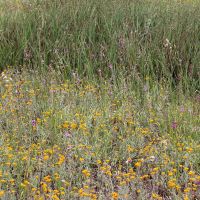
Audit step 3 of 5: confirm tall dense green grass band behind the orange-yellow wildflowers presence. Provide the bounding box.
[0,0,200,92]
